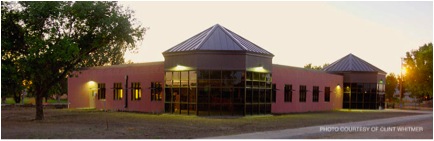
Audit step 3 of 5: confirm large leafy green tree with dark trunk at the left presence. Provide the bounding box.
[1,1,146,120]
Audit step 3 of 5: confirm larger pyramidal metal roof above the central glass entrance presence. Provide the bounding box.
[163,24,274,56]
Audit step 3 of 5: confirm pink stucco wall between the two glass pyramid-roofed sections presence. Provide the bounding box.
[271,65,343,114]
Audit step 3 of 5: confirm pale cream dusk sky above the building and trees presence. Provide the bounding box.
[119,1,433,74]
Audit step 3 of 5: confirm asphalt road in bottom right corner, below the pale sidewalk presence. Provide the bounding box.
[303,115,433,139]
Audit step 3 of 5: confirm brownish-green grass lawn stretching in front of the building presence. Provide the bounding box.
[1,107,415,139]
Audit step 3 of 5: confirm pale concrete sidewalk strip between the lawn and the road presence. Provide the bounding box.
[208,110,433,139]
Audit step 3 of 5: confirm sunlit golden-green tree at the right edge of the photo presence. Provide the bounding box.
[403,43,433,101]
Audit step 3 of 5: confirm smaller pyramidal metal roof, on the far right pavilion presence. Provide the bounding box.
[323,53,386,74]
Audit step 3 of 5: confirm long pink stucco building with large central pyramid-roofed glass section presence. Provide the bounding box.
[68,24,384,116]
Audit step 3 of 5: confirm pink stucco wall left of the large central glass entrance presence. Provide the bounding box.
[68,62,164,113]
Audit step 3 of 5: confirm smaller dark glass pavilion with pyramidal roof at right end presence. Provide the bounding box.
[323,54,386,109]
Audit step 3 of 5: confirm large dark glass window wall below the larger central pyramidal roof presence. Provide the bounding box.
[165,70,276,115]
